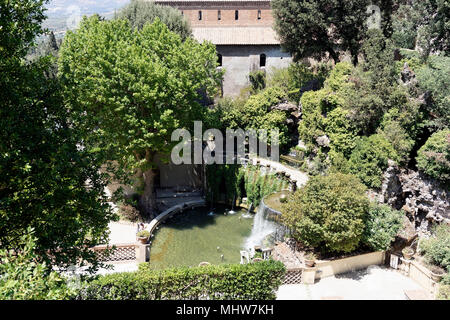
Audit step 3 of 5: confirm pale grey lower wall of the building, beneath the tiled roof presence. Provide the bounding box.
[217,45,292,96]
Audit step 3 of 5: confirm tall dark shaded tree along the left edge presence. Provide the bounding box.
[0,0,113,268]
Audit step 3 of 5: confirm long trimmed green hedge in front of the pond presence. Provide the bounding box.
[76,260,286,300]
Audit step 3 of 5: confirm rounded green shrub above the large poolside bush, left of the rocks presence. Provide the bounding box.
[349,134,397,188]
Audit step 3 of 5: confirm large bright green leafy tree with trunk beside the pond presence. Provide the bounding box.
[59,16,221,217]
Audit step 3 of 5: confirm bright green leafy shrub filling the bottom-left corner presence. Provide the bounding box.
[0,228,73,300]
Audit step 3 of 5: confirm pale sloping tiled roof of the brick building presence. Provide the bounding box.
[192,27,280,45]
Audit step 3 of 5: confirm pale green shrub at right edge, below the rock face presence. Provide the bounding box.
[419,224,450,270]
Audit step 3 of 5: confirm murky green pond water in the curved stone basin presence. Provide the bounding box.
[150,207,253,269]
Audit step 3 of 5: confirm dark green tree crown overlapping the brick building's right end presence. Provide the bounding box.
[272,0,370,63]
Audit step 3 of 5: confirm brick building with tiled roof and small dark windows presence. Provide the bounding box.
[151,0,291,96]
